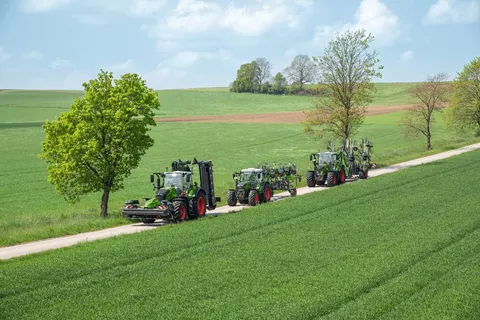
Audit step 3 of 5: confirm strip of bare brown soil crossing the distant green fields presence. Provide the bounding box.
[155,105,412,124]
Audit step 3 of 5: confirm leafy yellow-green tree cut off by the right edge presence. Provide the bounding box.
[445,57,480,136]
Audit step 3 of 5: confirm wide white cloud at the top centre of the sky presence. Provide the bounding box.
[142,0,313,52]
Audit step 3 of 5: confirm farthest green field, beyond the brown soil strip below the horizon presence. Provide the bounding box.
[0,83,412,123]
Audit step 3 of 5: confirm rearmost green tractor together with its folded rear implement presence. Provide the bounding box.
[307,139,375,187]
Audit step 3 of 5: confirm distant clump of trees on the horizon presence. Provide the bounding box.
[230,55,318,94]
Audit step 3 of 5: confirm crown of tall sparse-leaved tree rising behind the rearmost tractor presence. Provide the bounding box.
[302,30,383,139]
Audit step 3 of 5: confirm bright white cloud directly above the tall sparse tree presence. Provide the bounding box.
[312,0,401,46]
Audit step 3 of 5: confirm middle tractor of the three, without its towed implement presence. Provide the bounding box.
[227,168,273,207]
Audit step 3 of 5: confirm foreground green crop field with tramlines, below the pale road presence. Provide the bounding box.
[0,151,480,319]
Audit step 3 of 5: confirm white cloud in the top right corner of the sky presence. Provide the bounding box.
[423,0,480,24]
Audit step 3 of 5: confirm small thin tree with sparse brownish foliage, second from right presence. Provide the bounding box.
[400,73,451,150]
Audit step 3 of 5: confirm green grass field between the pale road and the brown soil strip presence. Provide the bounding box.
[0,113,479,246]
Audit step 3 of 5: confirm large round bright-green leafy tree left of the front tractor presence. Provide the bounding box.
[40,70,160,217]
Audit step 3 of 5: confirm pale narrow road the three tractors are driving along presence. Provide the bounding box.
[0,143,480,260]
